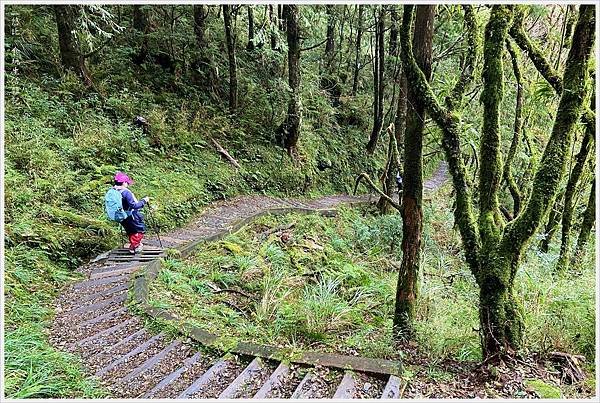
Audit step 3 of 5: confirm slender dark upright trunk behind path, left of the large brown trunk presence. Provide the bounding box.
[367,6,385,154]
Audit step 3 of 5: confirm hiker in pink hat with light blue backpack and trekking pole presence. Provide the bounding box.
[114,172,150,254]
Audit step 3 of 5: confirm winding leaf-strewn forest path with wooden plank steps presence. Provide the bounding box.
[50,163,447,398]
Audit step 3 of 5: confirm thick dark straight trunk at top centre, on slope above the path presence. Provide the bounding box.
[283,5,302,158]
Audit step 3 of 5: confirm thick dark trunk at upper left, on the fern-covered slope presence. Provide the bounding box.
[53,5,92,85]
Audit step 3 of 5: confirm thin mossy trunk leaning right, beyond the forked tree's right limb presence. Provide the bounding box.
[555,120,594,272]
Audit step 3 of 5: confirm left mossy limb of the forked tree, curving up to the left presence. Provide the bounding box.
[400,5,480,273]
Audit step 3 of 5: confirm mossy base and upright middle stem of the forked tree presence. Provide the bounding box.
[476,6,523,356]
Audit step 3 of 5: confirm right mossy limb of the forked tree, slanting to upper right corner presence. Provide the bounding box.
[501,5,595,257]
